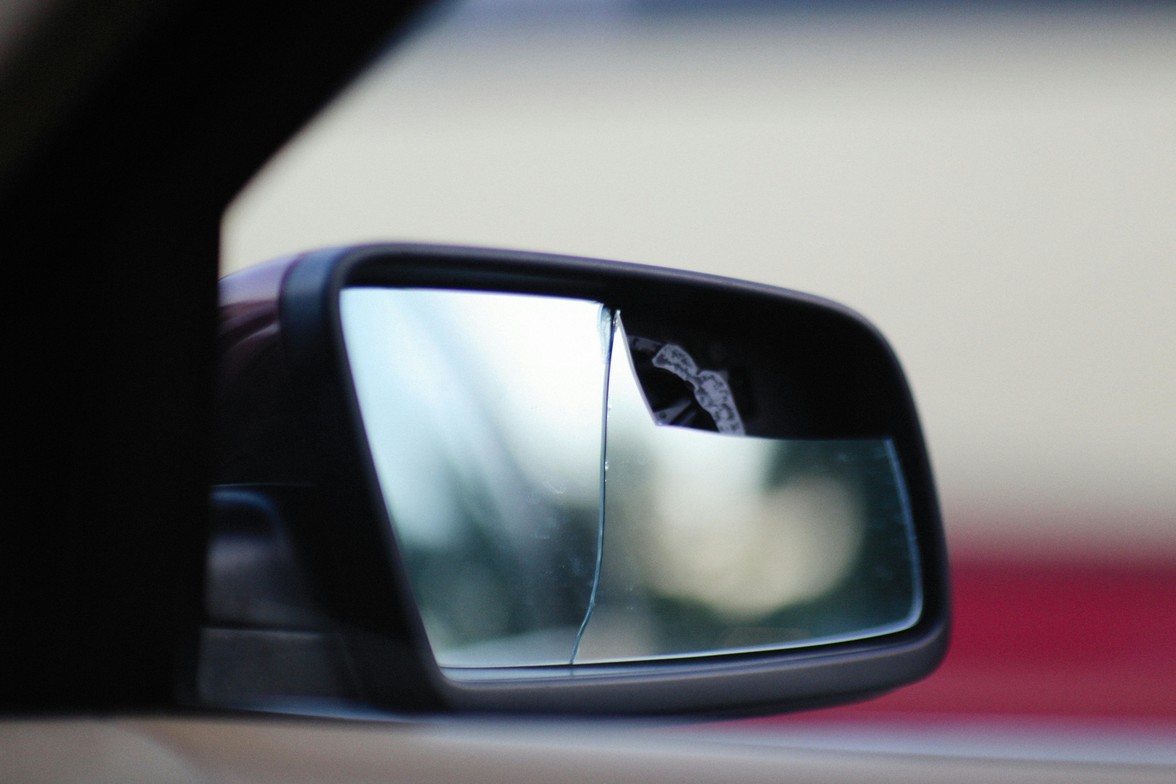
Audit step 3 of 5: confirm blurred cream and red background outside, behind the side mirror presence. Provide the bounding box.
[222,0,1176,749]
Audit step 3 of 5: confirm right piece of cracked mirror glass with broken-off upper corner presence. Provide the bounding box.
[576,322,921,663]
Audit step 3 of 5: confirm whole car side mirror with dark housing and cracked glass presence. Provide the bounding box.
[206,244,948,713]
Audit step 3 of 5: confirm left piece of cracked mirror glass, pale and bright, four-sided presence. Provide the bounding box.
[341,288,597,665]
